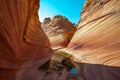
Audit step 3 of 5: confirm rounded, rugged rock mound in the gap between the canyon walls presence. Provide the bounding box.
[42,15,76,49]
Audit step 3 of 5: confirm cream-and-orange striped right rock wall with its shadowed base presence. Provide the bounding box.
[62,0,120,80]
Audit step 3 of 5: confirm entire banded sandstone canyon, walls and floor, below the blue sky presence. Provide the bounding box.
[0,0,120,80]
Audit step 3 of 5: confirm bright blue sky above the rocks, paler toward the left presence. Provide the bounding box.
[39,0,85,24]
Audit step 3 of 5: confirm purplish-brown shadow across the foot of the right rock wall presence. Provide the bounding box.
[67,63,120,80]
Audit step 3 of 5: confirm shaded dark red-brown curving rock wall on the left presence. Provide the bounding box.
[0,0,51,80]
